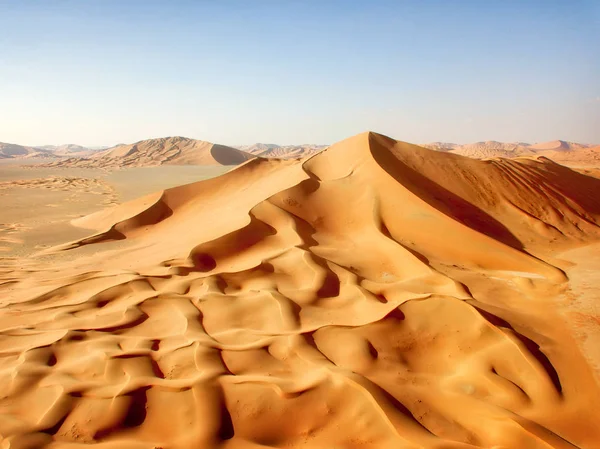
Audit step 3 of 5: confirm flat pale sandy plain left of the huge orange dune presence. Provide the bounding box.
[0,159,233,257]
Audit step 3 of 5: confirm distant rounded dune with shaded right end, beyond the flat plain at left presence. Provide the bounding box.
[43,137,253,169]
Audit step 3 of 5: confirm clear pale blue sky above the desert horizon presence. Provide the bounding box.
[0,0,600,145]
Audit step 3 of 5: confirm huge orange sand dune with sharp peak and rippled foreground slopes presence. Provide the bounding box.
[0,133,600,449]
